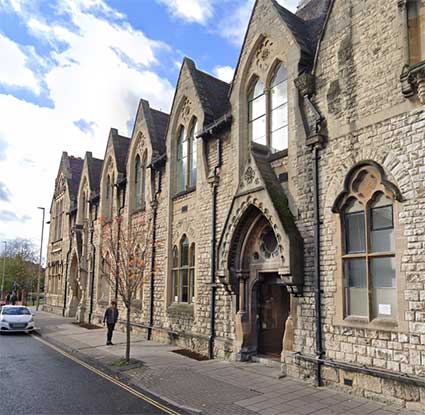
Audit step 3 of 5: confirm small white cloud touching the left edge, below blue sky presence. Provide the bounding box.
[0,33,40,94]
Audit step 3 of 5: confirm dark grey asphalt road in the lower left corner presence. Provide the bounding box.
[0,334,176,415]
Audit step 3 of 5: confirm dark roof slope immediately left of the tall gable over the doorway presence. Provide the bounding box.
[183,58,230,124]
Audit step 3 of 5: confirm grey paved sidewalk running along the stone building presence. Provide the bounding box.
[31,311,418,415]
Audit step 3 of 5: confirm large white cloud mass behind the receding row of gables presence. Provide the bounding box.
[0,0,174,250]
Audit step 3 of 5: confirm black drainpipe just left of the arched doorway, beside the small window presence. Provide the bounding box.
[208,138,221,359]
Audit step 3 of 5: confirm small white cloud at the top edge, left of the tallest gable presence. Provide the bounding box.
[157,0,215,25]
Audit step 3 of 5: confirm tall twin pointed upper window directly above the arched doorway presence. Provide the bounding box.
[248,64,288,153]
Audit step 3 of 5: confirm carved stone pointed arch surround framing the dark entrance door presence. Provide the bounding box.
[219,204,294,360]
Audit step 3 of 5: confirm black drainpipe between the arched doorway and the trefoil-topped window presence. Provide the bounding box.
[313,145,323,386]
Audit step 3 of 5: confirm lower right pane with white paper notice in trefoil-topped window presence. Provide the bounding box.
[370,257,397,318]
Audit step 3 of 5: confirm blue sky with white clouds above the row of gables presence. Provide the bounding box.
[0,0,298,260]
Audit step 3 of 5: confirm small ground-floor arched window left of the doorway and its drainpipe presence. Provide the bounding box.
[172,235,195,303]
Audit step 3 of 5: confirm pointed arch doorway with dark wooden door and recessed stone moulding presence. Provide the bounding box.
[228,206,293,360]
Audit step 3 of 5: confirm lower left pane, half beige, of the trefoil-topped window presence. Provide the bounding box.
[344,259,368,316]
